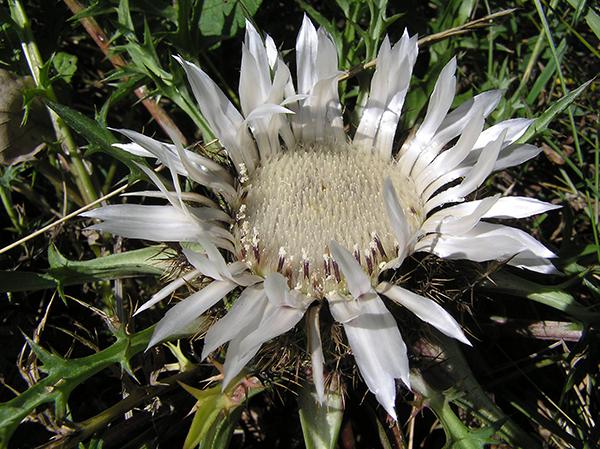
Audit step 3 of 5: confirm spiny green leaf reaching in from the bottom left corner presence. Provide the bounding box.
[0,327,154,449]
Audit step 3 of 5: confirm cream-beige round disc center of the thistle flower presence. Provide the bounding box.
[237,144,423,294]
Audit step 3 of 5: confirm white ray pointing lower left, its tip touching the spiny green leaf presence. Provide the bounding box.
[148,281,237,348]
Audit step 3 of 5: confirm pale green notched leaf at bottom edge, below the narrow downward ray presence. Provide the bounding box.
[298,383,344,449]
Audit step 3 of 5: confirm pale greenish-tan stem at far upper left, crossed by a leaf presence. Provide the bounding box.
[9,0,98,203]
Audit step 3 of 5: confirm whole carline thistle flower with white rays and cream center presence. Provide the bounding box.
[84,17,556,418]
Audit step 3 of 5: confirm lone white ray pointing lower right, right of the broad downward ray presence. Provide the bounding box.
[377,282,472,346]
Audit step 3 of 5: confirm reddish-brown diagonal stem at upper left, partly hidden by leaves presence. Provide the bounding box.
[64,0,187,145]
